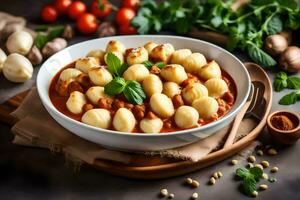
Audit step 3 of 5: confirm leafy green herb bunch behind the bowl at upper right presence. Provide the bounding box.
[131,0,300,67]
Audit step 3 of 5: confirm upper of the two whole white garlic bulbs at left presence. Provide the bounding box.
[6,31,33,55]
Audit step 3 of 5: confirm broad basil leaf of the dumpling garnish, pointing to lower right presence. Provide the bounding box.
[123,80,146,105]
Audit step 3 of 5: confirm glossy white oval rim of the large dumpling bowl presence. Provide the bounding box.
[36,35,251,137]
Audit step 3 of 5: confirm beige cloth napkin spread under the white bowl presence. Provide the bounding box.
[12,88,256,164]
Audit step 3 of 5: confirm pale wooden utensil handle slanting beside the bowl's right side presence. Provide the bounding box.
[223,101,251,148]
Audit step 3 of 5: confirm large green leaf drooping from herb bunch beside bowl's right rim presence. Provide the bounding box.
[248,44,276,67]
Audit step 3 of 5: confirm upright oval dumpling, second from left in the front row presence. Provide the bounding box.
[113,108,136,132]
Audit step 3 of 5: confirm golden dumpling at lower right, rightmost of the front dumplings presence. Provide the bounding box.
[192,97,219,119]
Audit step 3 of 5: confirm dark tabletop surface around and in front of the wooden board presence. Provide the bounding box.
[0,0,300,200]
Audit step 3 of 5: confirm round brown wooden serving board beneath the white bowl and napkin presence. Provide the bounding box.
[0,63,273,179]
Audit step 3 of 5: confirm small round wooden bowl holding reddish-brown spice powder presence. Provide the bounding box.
[267,110,300,145]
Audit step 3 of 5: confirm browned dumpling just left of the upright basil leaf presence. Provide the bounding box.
[89,67,113,86]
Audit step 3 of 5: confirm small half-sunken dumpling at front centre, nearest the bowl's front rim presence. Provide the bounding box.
[140,117,164,133]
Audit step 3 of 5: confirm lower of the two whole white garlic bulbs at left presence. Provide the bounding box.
[3,53,33,83]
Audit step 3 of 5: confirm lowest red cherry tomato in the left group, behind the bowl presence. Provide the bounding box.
[77,13,98,34]
